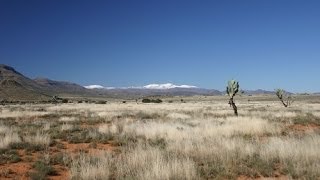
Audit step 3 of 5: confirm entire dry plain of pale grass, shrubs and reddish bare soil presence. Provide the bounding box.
[0,96,320,180]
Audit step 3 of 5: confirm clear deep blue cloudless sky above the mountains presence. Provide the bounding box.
[0,0,320,92]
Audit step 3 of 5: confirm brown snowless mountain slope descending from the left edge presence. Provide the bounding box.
[0,64,92,101]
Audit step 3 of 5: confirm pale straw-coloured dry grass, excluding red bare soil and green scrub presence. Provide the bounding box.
[0,97,320,179]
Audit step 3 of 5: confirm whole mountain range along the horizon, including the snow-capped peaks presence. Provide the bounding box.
[0,64,300,101]
